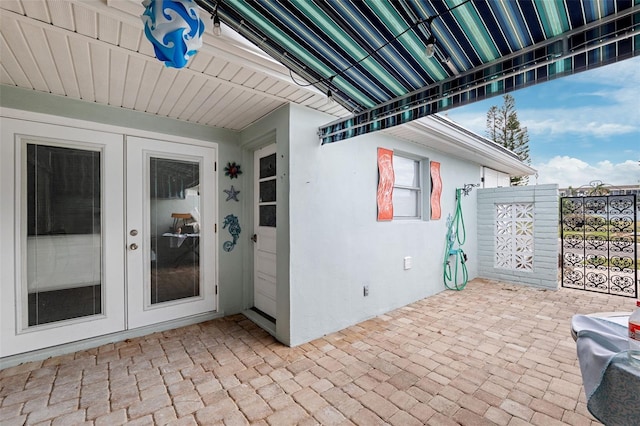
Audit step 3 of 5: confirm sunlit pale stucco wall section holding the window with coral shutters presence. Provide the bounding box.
[288,105,481,345]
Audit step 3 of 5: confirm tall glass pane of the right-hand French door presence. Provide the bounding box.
[149,157,201,305]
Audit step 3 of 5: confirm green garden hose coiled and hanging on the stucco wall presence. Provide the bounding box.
[443,188,469,290]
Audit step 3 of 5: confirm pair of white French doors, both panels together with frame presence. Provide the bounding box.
[0,117,217,357]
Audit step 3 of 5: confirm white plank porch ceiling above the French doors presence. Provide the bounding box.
[0,0,348,131]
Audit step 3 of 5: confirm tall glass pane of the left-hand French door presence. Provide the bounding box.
[26,143,103,326]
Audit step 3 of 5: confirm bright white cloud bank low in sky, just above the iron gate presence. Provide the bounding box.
[529,156,640,188]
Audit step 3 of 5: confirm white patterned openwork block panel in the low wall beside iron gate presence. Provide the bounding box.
[494,203,533,271]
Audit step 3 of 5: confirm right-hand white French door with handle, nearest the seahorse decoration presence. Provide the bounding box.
[126,137,217,328]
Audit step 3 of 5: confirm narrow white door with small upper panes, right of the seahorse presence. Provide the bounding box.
[253,144,277,319]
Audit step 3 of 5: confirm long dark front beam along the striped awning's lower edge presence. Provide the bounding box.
[318,5,640,145]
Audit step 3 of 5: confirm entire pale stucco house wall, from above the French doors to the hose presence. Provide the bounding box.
[2,88,500,360]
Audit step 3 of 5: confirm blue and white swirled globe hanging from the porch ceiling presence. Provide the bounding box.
[140,0,204,68]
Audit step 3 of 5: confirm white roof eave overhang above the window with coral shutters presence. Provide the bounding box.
[399,117,536,176]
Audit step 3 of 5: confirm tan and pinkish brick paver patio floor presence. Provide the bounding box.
[0,280,634,426]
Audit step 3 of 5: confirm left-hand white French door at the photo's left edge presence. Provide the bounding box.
[0,118,125,357]
